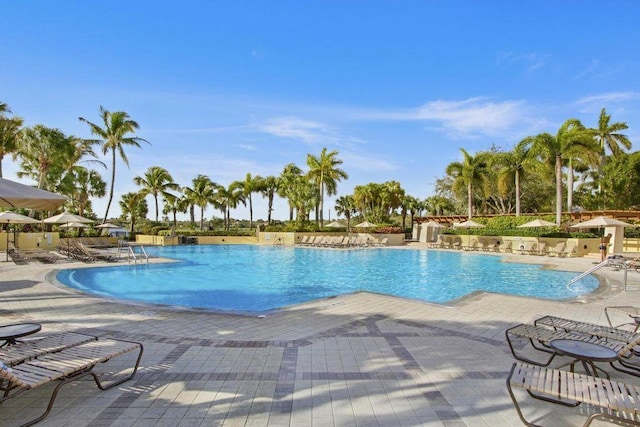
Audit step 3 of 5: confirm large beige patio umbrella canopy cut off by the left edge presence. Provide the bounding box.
[0,178,67,211]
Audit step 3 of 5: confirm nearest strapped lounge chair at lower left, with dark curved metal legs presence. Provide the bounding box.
[0,339,143,427]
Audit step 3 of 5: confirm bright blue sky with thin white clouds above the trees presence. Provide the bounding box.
[0,0,640,219]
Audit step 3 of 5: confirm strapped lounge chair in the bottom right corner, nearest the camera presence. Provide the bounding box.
[507,362,640,426]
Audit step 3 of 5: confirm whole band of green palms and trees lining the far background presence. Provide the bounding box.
[0,103,640,231]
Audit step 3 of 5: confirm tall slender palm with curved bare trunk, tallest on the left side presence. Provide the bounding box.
[79,106,149,223]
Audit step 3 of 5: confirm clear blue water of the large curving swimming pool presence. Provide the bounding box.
[57,245,599,311]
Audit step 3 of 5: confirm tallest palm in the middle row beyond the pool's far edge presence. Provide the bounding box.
[307,147,349,226]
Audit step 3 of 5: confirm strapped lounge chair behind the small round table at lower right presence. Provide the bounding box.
[505,324,640,376]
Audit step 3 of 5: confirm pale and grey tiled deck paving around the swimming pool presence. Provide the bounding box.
[0,246,640,427]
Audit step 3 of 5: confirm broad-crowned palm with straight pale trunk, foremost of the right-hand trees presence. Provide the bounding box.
[532,119,593,227]
